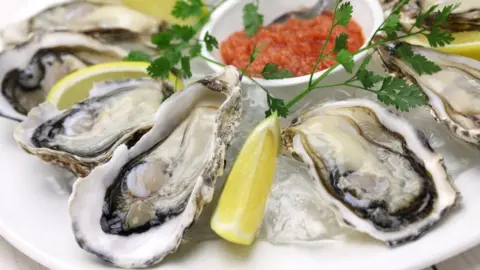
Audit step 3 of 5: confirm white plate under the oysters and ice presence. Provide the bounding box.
[0,0,480,270]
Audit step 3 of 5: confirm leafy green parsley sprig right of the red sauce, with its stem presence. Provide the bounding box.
[262,0,458,117]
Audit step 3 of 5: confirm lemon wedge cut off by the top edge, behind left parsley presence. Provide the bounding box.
[122,0,208,25]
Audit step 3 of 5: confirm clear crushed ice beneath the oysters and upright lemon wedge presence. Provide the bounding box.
[42,60,480,244]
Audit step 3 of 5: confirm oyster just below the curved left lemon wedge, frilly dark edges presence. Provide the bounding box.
[14,76,173,176]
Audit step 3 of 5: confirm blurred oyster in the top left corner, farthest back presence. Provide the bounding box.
[1,1,166,45]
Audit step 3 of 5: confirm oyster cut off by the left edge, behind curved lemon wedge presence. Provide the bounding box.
[0,32,128,119]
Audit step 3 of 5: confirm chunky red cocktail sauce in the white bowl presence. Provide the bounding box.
[220,12,365,77]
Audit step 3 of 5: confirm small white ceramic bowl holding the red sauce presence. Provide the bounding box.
[201,0,384,103]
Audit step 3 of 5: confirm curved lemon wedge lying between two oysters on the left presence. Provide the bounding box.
[47,62,183,110]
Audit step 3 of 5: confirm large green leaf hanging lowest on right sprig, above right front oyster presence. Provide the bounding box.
[376,77,427,112]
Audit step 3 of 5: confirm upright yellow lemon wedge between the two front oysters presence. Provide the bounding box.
[210,113,280,245]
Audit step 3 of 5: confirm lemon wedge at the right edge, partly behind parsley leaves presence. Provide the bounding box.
[405,31,480,60]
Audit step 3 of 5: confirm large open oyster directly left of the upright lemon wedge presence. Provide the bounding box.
[69,67,242,268]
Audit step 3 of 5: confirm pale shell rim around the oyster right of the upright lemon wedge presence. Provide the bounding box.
[282,98,462,247]
